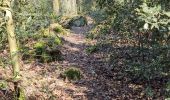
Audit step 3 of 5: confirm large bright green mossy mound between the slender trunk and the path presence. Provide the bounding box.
[34,37,63,62]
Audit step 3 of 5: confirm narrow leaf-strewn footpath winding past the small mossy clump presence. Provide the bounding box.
[53,23,117,100]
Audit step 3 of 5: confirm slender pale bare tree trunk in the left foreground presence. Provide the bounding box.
[1,0,25,100]
